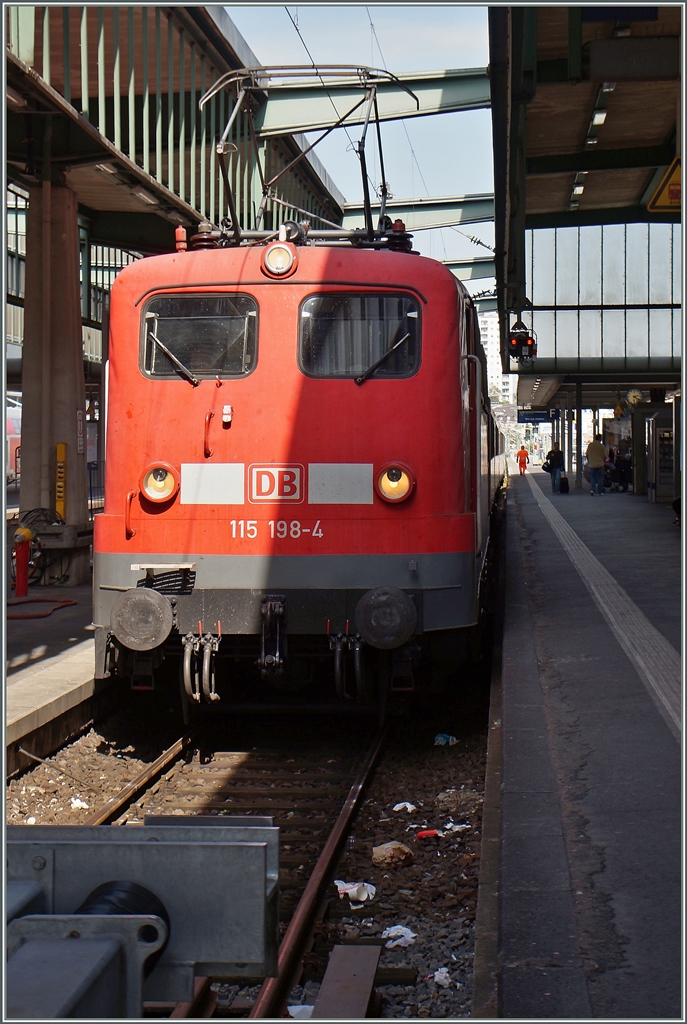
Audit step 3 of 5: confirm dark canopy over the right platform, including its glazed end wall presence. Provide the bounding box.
[489,5,682,397]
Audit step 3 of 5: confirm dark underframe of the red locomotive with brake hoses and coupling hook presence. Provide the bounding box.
[95,586,477,702]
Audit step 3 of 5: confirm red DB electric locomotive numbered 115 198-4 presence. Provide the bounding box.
[94,222,504,710]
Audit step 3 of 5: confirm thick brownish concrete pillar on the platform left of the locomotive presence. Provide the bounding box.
[19,180,89,585]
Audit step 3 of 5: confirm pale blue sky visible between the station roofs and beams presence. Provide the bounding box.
[220,3,493,278]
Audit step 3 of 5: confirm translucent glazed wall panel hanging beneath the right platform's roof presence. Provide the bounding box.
[523,223,682,373]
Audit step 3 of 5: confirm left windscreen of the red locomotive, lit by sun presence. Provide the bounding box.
[143,295,258,384]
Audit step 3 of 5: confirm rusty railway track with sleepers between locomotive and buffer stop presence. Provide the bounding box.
[80,730,385,1018]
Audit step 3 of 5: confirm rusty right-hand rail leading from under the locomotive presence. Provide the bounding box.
[250,727,386,1018]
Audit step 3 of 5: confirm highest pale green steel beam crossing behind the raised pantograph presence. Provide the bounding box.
[255,68,490,137]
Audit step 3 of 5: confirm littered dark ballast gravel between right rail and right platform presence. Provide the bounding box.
[331,730,486,1017]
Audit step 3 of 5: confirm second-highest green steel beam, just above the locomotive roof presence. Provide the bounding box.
[342,195,493,231]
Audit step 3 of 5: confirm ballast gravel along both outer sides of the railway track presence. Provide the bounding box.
[6,700,486,1018]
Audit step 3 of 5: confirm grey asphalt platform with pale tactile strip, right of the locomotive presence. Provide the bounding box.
[489,469,684,1020]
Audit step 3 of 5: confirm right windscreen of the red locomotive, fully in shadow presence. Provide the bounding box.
[299,293,420,380]
